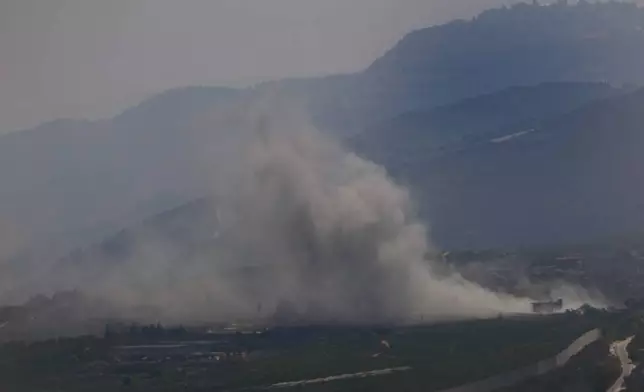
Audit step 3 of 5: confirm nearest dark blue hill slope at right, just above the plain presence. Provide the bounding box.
[388,90,644,248]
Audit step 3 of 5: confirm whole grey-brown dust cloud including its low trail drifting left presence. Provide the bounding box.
[73,101,530,323]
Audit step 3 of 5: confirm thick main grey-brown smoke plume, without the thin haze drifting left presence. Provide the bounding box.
[161,102,529,322]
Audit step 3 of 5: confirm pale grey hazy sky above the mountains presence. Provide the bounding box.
[0,0,572,132]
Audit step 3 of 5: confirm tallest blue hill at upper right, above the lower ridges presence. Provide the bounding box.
[304,2,644,132]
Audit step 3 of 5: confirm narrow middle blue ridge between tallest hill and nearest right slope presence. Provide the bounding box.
[350,83,625,164]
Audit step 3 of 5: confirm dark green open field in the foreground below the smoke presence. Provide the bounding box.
[0,312,615,392]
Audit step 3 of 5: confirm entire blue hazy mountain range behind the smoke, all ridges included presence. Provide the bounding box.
[0,1,644,288]
